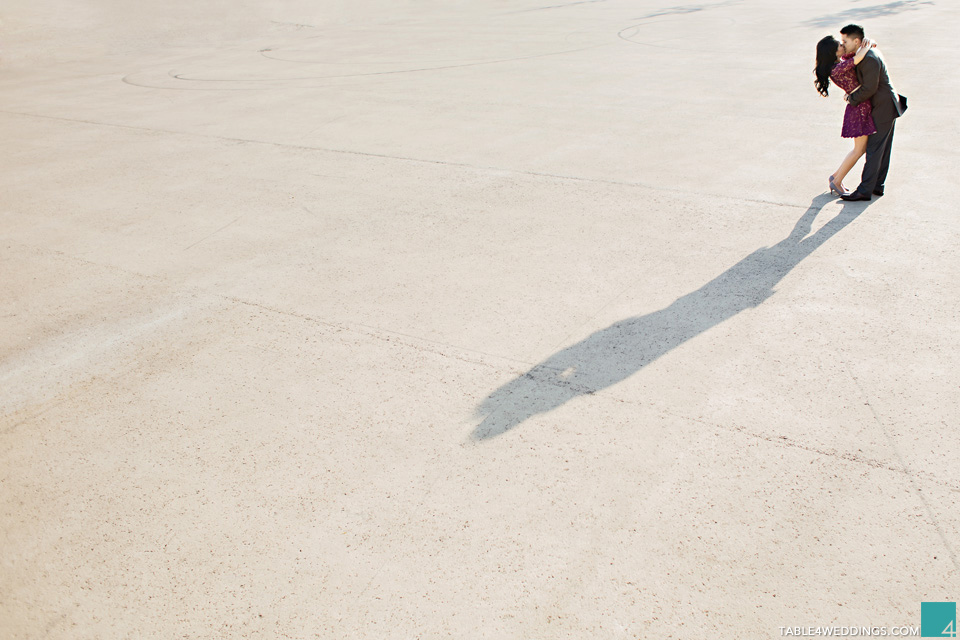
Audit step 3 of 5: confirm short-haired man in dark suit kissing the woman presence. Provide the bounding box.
[840,24,907,201]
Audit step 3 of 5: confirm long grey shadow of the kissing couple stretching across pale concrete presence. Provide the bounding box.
[470,195,870,440]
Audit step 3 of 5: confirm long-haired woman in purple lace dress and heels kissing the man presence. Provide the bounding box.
[813,36,877,195]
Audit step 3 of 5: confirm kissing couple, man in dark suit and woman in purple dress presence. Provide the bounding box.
[814,24,907,201]
